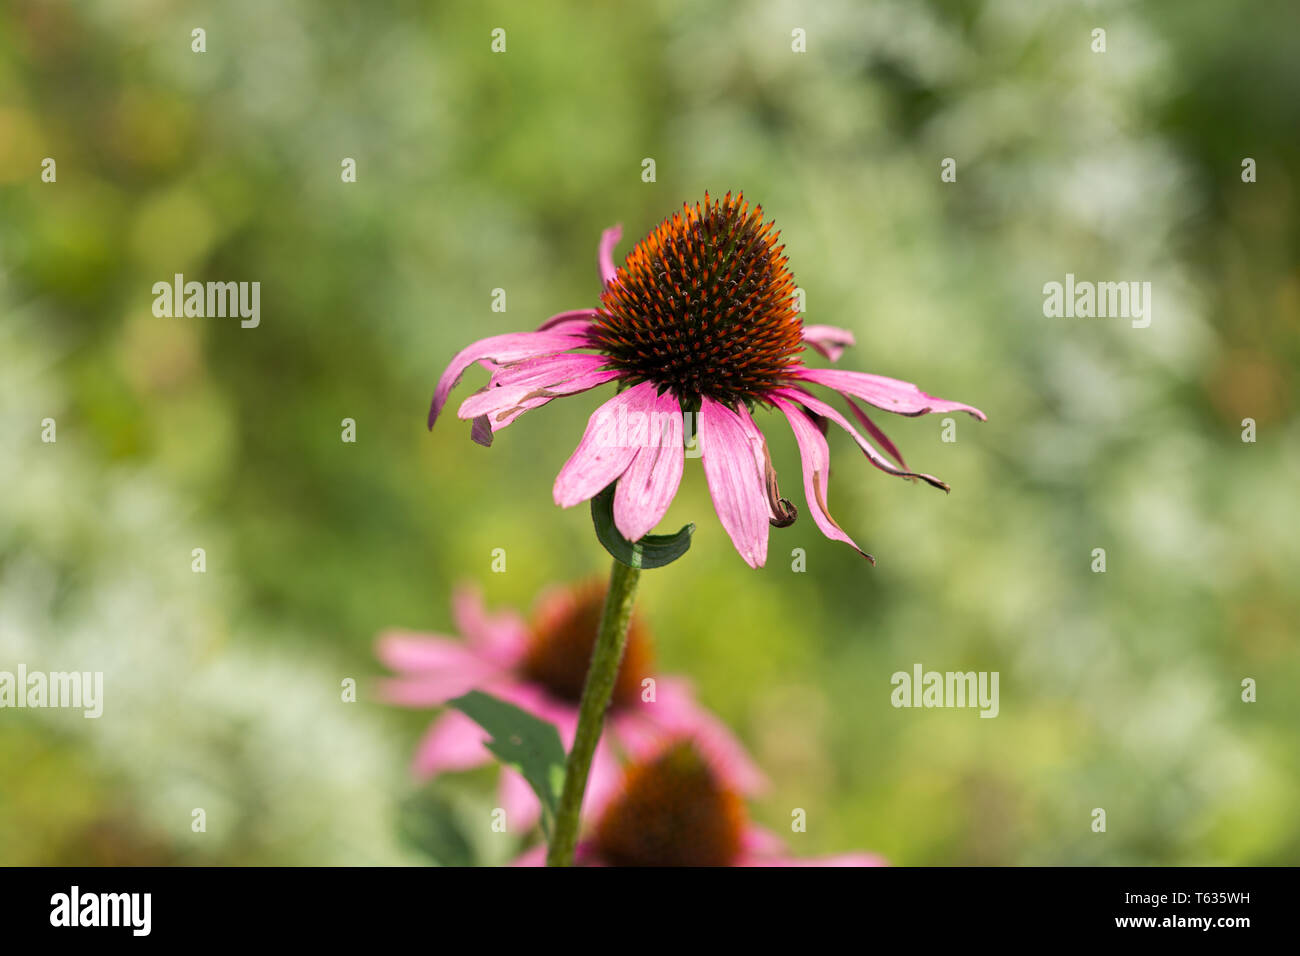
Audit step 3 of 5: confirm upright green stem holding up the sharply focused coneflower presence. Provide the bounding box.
[546,561,641,866]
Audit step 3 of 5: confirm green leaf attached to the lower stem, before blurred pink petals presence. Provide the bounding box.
[447,691,564,840]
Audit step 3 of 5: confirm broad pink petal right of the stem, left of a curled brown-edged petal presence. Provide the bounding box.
[699,397,768,567]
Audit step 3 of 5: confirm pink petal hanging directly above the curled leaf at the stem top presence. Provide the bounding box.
[614,392,685,541]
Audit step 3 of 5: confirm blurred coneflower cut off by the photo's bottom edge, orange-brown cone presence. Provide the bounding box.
[515,737,884,866]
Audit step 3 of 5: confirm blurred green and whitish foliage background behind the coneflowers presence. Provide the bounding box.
[0,0,1300,864]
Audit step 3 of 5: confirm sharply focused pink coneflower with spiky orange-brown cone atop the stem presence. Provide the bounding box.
[429,193,985,567]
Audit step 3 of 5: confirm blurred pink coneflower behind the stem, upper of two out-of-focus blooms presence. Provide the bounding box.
[377,583,763,830]
